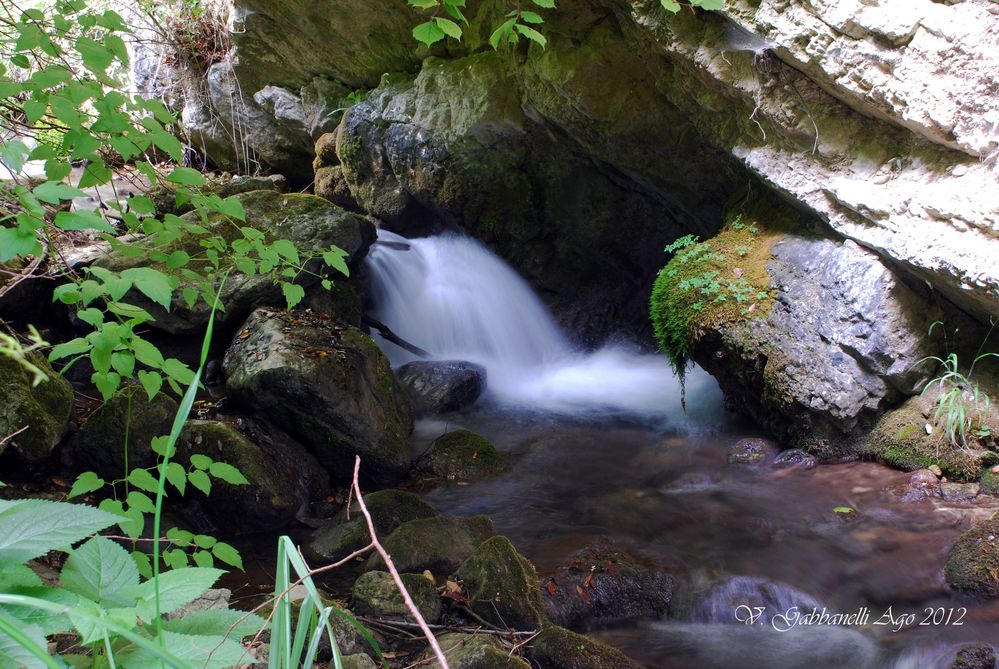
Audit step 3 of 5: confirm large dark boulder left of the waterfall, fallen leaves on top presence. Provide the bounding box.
[223,308,413,486]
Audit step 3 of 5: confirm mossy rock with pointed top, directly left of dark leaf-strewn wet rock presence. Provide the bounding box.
[457,536,548,630]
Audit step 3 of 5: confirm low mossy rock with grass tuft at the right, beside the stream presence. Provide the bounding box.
[860,396,995,481]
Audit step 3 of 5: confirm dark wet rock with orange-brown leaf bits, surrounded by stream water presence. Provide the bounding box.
[541,540,676,630]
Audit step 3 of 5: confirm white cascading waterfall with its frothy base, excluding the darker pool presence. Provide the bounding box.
[367,230,720,415]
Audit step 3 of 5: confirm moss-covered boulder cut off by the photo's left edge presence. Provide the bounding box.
[0,353,73,464]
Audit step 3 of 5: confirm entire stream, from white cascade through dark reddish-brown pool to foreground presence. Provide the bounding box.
[368,232,999,669]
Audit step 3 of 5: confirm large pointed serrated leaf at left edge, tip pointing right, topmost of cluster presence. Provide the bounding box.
[0,499,119,563]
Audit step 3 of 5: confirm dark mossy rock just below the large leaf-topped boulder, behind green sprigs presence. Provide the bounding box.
[177,420,329,534]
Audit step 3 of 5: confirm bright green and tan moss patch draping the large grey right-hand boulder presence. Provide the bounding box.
[651,190,791,379]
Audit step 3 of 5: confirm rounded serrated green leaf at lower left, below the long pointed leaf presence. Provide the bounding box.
[59,537,139,607]
